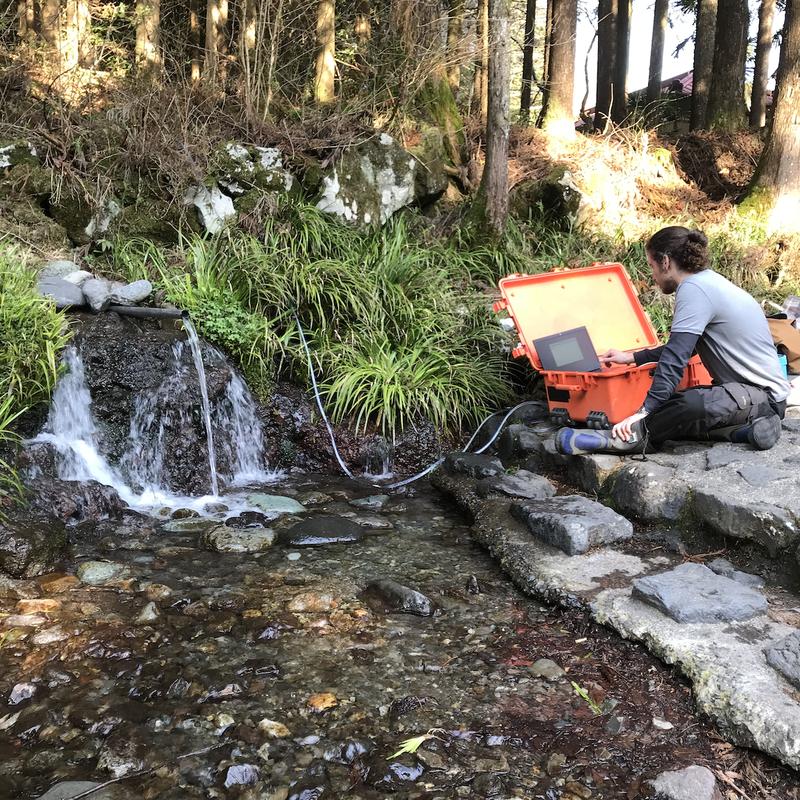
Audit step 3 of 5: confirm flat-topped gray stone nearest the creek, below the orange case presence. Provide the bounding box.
[511,495,633,556]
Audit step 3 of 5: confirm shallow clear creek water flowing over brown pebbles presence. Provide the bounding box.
[0,476,796,800]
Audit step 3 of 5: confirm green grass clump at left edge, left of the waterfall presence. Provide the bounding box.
[0,246,69,500]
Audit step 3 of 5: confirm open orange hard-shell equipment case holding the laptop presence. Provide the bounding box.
[494,264,711,428]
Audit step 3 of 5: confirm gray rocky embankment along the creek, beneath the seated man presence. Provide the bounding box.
[434,412,800,769]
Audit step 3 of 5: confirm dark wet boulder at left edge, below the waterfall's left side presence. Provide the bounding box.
[0,517,67,578]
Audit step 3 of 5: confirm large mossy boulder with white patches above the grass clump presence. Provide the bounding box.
[317,133,418,226]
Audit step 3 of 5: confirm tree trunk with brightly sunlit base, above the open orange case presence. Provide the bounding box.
[542,0,578,136]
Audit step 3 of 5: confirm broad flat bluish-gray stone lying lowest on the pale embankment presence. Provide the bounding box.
[633,563,767,622]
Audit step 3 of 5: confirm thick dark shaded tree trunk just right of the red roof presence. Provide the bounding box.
[707,0,750,132]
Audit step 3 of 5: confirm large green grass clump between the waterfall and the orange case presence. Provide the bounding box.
[115,205,508,435]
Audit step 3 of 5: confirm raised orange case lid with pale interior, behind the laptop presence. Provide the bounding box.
[495,264,658,365]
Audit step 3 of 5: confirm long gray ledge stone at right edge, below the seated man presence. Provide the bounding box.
[691,487,800,556]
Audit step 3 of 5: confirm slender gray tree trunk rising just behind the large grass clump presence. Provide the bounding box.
[477,0,510,239]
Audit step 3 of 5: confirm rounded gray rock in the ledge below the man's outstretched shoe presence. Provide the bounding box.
[611,462,689,522]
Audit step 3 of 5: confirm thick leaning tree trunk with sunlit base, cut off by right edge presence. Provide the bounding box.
[743,0,800,233]
